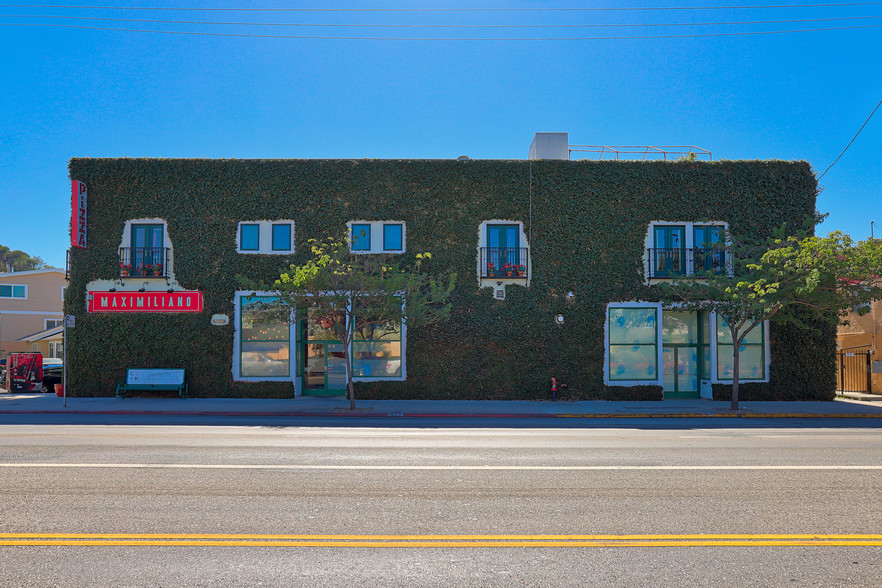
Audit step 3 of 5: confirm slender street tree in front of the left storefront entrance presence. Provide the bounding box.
[253,237,456,409]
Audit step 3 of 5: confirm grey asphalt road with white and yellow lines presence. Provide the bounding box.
[0,423,882,586]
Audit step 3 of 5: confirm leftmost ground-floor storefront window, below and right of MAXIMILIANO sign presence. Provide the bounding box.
[239,296,291,377]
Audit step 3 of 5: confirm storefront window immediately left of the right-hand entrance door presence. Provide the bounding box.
[609,307,658,381]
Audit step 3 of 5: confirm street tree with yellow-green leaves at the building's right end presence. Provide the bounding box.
[661,223,882,410]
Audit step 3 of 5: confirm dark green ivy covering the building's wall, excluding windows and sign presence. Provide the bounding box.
[65,159,835,400]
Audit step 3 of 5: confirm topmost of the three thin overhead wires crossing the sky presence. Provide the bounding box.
[0,2,882,12]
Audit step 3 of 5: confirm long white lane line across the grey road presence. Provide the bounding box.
[0,463,882,471]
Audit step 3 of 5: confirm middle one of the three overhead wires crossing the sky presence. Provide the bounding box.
[0,14,882,29]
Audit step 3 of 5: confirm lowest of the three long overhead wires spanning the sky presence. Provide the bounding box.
[0,23,882,41]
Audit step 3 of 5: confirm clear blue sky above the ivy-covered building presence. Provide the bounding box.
[0,0,882,266]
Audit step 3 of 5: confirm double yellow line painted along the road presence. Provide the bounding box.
[0,533,882,547]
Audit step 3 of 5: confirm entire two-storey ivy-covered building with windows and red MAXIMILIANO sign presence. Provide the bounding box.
[65,134,835,400]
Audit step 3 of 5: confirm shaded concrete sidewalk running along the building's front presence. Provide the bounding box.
[0,392,882,418]
